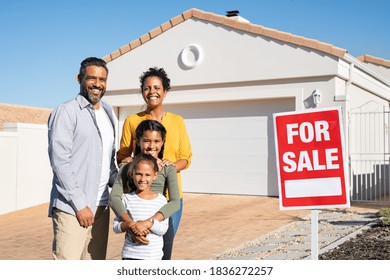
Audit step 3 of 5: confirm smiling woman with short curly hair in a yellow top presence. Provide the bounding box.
[117,67,192,234]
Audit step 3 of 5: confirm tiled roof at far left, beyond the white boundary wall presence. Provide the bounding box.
[0,103,52,130]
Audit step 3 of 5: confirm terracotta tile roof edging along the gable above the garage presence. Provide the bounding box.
[103,8,347,62]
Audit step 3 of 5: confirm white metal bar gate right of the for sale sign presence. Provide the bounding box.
[348,102,390,202]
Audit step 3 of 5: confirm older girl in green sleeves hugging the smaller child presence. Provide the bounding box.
[109,120,180,260]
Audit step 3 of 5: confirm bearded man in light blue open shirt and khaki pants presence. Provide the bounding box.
[48,57,117,260]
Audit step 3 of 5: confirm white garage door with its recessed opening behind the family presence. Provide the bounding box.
[165,99,295,196]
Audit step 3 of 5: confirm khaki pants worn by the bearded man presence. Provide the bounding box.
[52,206,110,260]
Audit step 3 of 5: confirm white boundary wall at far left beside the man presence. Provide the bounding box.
[0,123,52,215]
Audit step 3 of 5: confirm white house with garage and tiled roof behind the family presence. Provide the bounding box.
[104,9,390,200]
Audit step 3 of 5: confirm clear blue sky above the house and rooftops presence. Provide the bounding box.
[0,0,390,108]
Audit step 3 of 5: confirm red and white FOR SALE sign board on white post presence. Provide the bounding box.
[274,108,350,210]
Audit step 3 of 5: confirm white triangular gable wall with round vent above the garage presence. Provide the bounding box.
[107,19,337,92]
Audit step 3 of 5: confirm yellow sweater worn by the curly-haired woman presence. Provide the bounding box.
[117,112,192,197]
